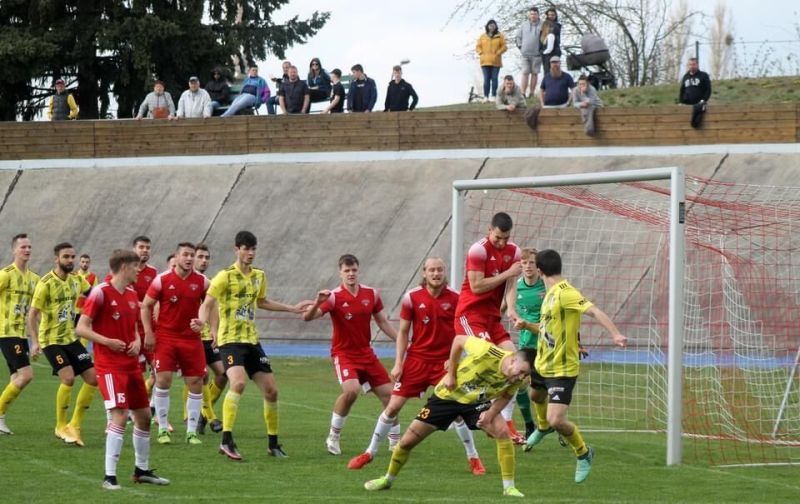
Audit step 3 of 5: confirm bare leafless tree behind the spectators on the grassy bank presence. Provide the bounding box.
[453,0,700,86]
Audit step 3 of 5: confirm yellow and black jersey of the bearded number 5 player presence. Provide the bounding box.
[31,271,92,348]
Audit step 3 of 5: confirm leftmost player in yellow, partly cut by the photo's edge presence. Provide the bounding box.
[0,233,39,435]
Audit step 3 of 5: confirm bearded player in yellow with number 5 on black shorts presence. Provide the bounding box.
[28,242,97,446]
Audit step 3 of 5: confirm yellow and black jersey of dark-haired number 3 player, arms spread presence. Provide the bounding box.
[206,264,267,346]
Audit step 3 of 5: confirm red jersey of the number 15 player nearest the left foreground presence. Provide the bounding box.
[83,282,139,373]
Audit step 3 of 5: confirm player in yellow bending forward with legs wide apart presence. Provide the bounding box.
[364,336,535,497]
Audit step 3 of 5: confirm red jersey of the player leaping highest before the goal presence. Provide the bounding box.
[456,238,522,318]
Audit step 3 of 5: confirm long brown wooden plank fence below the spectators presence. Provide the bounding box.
[0,103,800,160]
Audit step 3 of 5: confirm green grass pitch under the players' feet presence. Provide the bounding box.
[0,358,800,504]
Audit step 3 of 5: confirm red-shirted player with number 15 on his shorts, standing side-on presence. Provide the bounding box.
[76,250,169,490]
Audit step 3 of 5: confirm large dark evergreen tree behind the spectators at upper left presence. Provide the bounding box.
[0,0,330,120]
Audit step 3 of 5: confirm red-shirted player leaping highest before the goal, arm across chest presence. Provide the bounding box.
[455,212,525,445]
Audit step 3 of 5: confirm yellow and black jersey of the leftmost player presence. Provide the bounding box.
[0,263,39,338]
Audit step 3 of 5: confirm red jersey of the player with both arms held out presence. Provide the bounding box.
[320,284,383,355]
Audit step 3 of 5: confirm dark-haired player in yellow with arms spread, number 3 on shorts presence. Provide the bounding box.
[192,231,312,460]
